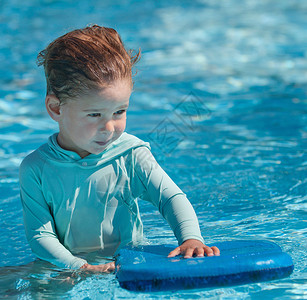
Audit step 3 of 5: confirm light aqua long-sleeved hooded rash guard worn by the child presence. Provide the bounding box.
[20,133,204,269]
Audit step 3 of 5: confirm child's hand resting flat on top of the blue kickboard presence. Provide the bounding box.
[168,239,220,258]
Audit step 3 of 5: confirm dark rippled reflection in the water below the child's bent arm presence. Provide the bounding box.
[0,260,115,299]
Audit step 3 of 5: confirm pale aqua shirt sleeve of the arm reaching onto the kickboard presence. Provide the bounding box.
[133,147,204,245]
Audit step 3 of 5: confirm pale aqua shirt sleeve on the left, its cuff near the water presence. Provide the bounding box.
[19,157,87,269]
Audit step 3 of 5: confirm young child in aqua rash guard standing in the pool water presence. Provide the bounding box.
[20,25,219,272]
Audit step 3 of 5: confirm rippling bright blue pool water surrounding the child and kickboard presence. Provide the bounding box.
[0,0,307,300]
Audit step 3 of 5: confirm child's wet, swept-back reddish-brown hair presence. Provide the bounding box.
[37,25,140,102]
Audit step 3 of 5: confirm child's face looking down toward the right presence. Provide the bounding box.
[58,80,132,157]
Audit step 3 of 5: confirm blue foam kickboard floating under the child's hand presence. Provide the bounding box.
[115,240,294,291]
